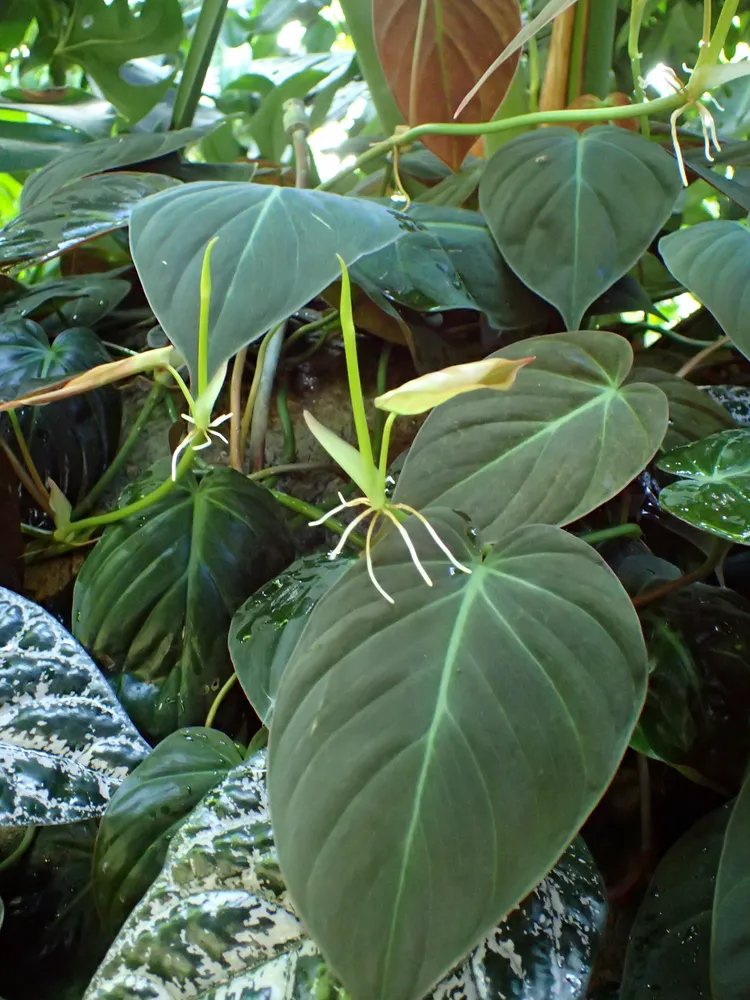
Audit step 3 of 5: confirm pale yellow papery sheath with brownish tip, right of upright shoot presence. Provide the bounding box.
[375,358,534,416]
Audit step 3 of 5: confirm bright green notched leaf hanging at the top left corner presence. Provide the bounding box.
[55,0,184,123]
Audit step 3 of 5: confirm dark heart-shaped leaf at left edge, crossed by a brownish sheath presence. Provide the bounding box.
[0,320,122,503]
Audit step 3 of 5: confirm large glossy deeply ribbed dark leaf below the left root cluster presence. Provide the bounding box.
[73,468,293,739]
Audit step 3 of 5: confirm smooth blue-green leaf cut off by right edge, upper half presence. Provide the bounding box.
[659,219,750,357]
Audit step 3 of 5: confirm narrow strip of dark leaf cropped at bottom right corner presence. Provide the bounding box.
[711,778,750,1000]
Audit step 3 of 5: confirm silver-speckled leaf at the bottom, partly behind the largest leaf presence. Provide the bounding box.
[84,751,605,1000]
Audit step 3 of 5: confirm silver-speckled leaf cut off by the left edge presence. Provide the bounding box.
[0,588,150,826]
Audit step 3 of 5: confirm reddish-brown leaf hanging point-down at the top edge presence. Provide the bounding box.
[373,0,521,170]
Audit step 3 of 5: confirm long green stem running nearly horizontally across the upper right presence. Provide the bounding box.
[316,92,685,191]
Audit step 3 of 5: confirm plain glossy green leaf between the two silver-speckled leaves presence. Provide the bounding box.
[93,728,243,932]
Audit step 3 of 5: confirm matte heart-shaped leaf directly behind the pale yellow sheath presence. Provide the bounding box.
[395,331,667,540]
